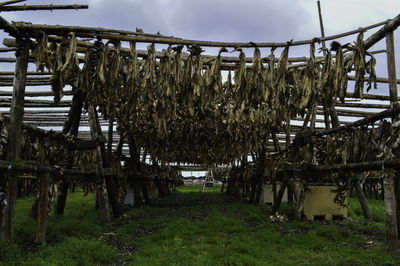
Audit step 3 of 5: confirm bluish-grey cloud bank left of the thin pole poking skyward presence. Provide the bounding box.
[5,0,312,41]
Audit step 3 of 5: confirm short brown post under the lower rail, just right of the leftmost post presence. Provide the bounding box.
[35,173,50,244]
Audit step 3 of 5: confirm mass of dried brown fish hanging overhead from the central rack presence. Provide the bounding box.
[33,34,375,163]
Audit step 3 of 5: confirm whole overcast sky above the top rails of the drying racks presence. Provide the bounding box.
[1,0,400,88]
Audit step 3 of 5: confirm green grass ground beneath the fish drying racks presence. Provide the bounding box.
[0,186,400,265]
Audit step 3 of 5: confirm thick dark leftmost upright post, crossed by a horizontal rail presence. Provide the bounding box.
[0,39,29,243]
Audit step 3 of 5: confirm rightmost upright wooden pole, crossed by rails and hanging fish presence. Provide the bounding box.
[383,32,399,241]
